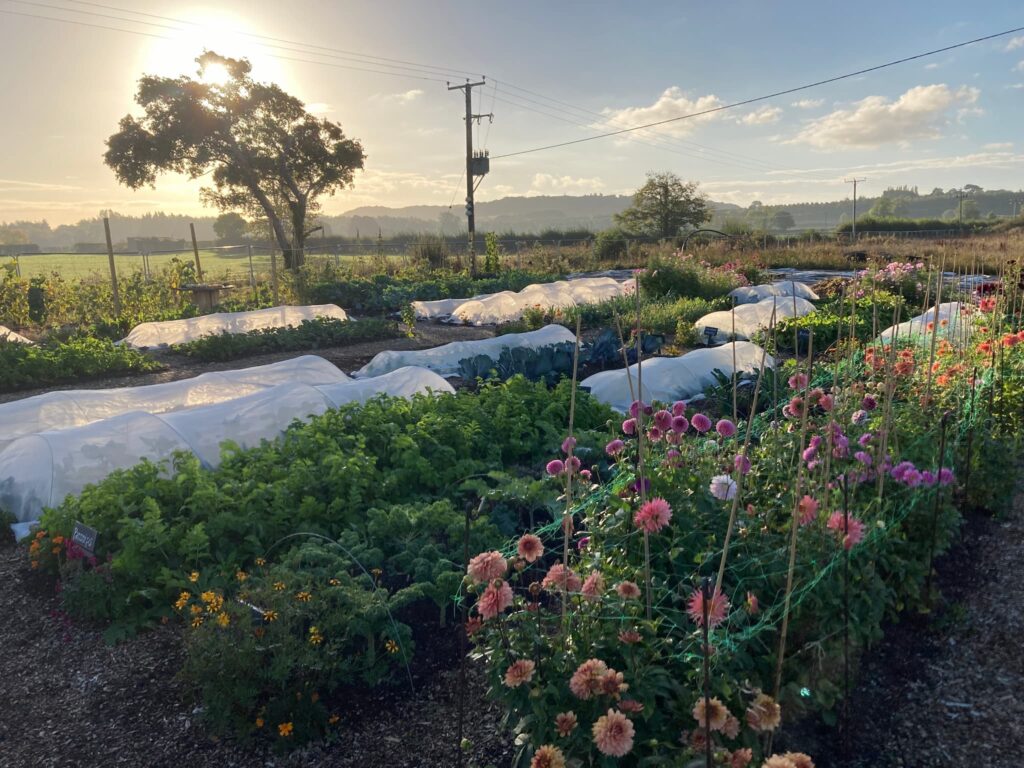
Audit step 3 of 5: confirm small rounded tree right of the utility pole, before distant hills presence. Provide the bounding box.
[615,172,711,238]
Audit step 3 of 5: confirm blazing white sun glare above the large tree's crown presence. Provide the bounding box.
[139,7,290,89]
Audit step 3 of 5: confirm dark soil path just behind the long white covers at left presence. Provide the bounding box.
[0,323,495,402]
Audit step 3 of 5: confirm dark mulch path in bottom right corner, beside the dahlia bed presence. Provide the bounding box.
[786,494,1024,768]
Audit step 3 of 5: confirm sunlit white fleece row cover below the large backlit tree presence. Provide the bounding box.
[121,304,348,348]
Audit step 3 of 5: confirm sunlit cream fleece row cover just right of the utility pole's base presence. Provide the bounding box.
[413,278,636,326]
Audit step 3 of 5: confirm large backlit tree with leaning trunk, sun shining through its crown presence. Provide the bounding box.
[103,51,366,267]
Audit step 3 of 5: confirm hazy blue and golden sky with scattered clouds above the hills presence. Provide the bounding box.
[0,0,1024,224]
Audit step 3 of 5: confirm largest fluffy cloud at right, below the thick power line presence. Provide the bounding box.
[791,83,981,150]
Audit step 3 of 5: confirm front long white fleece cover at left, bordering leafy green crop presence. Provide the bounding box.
[0,368,455,538]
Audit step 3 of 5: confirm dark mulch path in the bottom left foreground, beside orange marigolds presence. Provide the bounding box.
[0,545,512,768]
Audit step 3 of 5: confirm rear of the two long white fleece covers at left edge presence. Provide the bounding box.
[0,354,348,449]
